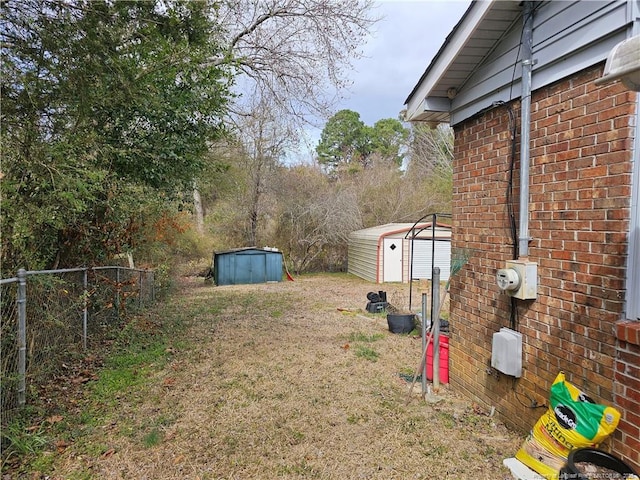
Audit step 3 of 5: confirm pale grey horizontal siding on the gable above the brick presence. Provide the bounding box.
[450,0,633,125]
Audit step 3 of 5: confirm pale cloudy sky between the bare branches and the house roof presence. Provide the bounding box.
[290,0,471,163]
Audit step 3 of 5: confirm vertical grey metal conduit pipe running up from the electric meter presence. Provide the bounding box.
[518,1,534,258]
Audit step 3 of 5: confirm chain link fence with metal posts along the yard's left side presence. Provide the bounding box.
[0,266,155,424]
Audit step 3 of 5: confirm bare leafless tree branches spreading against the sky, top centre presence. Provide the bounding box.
[211,0,377,125]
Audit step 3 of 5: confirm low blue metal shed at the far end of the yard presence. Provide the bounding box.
[212,247,282,285]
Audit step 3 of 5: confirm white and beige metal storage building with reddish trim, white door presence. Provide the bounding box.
[347,223,451,283]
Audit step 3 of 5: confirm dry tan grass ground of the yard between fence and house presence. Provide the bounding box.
[55,275,522,480]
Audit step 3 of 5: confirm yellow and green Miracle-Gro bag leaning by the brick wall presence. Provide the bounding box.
[516,372,620,479]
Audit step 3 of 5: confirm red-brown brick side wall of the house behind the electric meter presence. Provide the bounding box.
[450,62,639,468]
